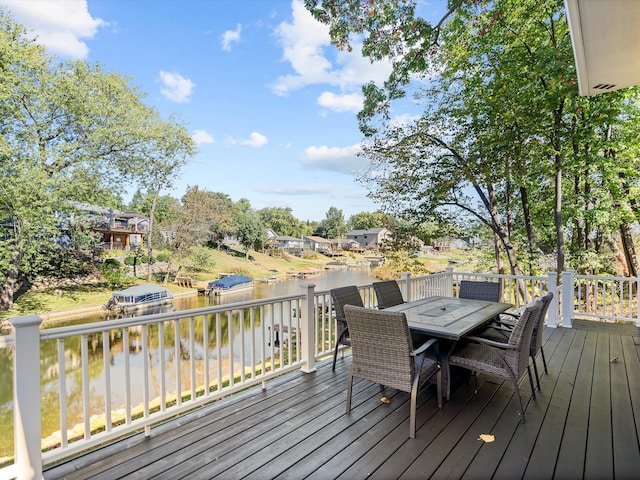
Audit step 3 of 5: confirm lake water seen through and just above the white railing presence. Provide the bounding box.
[0,269,375,458]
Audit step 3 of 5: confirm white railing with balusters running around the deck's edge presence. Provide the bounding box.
[0,269,640,478]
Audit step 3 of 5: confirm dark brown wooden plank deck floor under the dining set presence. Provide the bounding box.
[44,321,640,480]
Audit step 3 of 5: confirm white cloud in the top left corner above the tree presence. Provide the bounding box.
[0,0,108,59]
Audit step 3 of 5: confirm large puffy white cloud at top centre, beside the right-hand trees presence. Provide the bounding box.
[272,0,391,95]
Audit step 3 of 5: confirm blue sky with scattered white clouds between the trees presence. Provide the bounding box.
[0,0,445,221]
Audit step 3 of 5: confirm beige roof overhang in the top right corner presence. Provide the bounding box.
[564,0,640,95]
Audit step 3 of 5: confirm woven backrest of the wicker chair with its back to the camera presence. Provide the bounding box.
[344,305,414,392]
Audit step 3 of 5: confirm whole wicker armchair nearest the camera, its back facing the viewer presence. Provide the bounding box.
[344,305,442,438]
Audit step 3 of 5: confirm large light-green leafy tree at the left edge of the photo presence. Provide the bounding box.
[0,12,195,310]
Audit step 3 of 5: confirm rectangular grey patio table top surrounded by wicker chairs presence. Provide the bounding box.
[385,296,511,340]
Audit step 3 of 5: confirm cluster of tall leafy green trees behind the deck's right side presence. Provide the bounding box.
[307,0,639,282]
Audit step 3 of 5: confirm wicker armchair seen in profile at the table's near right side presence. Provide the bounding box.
[449,300,542,422]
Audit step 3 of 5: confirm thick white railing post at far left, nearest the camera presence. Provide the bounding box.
[10,315,42,480]
